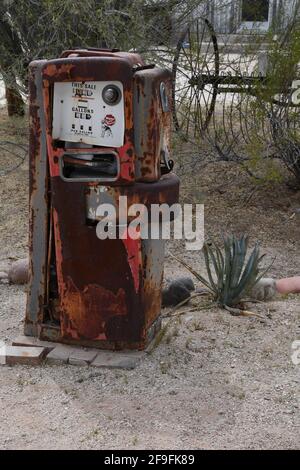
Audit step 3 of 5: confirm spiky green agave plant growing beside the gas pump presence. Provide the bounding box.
[176,235,269,309]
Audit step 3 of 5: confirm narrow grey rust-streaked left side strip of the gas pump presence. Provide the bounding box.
[25,61,49,336]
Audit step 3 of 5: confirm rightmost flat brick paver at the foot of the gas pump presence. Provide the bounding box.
[91,351,145,369]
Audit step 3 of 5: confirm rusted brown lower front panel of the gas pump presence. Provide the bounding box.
[51,177,144,342]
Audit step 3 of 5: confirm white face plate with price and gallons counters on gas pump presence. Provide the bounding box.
[52,81,125,147]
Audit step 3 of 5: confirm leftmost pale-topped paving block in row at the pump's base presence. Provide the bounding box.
[0,346,46,366]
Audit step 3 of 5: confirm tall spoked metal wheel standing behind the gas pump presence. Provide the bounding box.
[172,18,220,143]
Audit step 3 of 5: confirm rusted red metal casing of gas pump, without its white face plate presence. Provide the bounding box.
[25,51,179,349]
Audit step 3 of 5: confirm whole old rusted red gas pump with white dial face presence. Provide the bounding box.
[25,50,179,349]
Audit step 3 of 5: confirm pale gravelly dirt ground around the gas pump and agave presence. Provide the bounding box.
[0,112,300,449]
